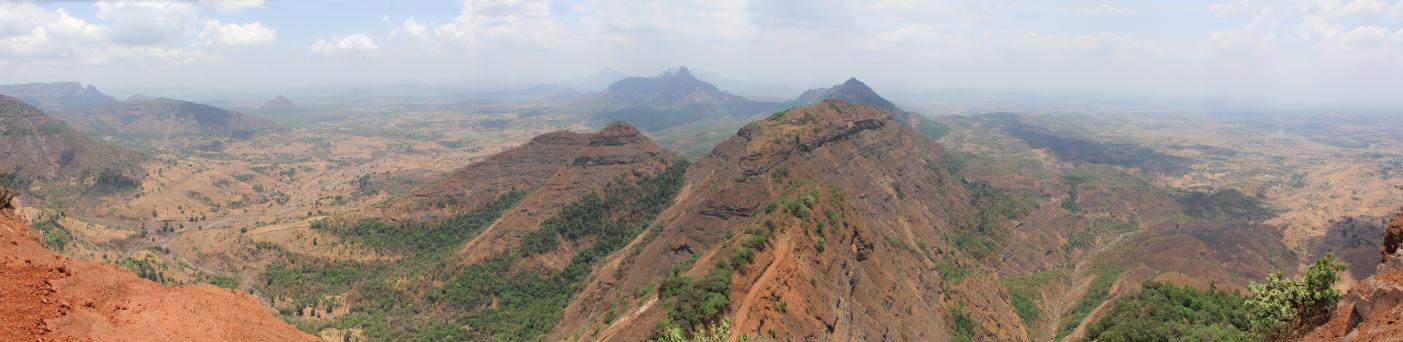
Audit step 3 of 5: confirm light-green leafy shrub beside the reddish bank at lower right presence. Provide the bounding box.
[1246,255,1344,339]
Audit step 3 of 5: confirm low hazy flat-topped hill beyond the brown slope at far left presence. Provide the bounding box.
[55,98,278,137]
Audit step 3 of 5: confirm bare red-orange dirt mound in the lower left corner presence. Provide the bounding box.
[0,210,316,341]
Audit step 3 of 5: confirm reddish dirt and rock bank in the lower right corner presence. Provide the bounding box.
[1305,207,1403,341]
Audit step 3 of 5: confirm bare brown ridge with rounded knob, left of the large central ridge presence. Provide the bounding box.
[383,123,676,220]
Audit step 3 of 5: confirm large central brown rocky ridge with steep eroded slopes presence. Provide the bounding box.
[549,100,1027,341]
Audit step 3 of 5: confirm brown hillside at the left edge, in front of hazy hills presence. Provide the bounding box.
[0,95,137,181]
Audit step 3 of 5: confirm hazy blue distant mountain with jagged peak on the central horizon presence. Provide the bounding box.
[592,67,780,132]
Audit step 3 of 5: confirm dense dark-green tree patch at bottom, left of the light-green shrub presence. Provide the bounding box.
[1086,282,1263,341]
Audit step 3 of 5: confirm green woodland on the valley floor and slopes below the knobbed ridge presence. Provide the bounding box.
[257,161,687,341]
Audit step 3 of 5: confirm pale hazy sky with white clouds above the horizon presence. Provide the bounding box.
[0,0,1403,107]
